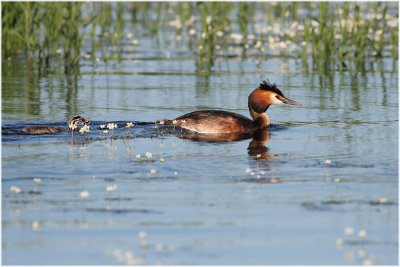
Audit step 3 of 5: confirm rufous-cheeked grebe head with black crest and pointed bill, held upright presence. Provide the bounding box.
[249,80,301,113]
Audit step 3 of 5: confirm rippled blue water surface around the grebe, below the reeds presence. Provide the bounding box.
[2,28,398,265]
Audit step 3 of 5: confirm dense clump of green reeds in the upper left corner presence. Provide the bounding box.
[2,2,90,72]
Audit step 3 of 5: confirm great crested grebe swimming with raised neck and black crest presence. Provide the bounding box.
[156,80,301,134]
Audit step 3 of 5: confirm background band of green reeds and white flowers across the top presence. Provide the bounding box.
[2,2,398,74]
